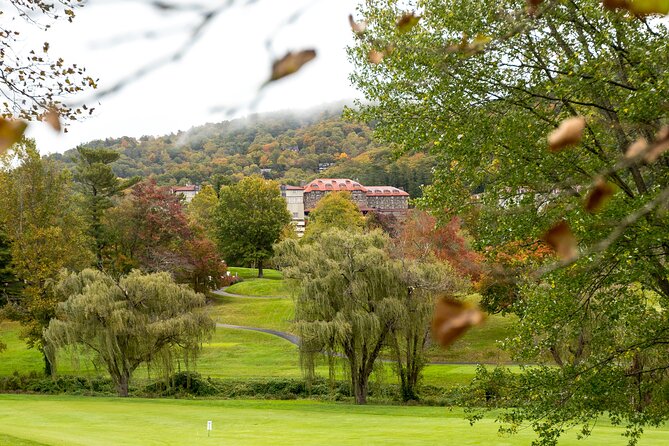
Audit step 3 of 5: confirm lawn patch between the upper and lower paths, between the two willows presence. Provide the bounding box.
[211,296,295,331]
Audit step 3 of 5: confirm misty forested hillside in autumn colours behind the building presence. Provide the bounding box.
[50,106,434,197]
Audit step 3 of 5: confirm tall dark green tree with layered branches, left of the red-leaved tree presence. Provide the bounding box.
[74,146,139,269]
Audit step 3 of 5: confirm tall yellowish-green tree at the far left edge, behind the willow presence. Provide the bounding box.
[0,141,92,373]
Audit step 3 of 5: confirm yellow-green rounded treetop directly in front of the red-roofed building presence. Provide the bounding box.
[304,191,365,240]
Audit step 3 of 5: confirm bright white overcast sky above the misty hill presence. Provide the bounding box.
[20,0,359,153]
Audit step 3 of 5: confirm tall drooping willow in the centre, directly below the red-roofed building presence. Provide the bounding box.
[276,229,403,404]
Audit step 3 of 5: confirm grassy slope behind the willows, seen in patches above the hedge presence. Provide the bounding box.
[0,272,513,385]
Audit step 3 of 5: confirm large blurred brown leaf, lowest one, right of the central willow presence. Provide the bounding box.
[432,296,485,347]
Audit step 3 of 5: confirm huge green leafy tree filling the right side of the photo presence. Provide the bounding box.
[350,0,669,444]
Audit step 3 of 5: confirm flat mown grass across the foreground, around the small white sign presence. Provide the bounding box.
[0,395,669,446]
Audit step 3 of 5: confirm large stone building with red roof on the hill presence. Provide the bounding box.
[281,178,409,236]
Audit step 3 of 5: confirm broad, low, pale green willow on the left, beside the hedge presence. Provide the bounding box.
[44,269,215,396]
